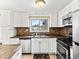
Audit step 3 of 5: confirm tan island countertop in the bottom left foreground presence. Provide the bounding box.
[0,44,20,59]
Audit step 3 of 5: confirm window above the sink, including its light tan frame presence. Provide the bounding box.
[29,16,50,32]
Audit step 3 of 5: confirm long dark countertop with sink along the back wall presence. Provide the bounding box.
[11,36,68,39]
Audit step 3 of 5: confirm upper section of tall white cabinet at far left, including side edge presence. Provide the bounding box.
[0,10,13,27]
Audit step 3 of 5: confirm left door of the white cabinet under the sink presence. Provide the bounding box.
[32,38,40,54]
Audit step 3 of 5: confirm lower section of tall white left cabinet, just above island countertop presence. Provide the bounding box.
[1,27,15,44]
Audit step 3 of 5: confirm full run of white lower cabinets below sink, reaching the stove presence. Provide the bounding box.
[32,38,56,54]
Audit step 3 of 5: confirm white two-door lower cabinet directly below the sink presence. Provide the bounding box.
[32,38,48,54]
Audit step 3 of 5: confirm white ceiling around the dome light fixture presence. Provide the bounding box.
[0,0,72,13]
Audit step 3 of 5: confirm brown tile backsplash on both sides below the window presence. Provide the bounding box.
[15,27,72,36]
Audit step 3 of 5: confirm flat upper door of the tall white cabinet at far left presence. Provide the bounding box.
[0,10,10,26]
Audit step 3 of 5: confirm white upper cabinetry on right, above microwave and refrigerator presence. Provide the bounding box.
[58,0,79,27]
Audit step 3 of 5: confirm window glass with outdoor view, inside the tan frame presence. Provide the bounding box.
[31,19,48,32]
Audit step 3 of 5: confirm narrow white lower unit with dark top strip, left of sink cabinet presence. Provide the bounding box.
[20,39,31,53]
